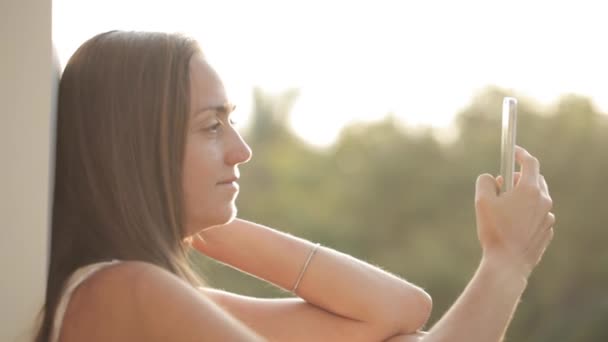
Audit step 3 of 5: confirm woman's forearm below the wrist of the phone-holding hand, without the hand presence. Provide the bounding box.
[422,258,527,342]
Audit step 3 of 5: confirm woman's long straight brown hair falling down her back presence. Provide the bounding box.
[36,31,200,342]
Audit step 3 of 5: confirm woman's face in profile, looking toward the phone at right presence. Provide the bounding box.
[183,55,251,235]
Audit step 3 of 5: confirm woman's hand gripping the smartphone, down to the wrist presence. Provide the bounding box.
[475,146,555,278]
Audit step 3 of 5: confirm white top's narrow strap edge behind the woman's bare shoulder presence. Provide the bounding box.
[49,260,118,342]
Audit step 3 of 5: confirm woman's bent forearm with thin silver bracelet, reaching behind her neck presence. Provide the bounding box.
[197,220,431,333]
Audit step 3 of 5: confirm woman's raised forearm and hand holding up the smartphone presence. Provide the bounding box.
[389,148,555,342]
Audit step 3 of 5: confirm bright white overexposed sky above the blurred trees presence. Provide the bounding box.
[53,0,608,145]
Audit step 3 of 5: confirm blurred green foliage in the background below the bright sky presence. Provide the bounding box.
[195,88,608,342]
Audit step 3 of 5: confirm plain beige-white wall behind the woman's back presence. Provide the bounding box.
[0,0,58,341]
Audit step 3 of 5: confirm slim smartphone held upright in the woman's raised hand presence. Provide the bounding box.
[500,97,517,192]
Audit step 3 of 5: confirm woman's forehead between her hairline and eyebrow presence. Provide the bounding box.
[190,54,228,110]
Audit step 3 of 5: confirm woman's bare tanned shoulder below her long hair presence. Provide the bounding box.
[61,261,256,342]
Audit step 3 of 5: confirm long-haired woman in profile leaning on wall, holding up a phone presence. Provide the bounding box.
[36,31,554,342]
